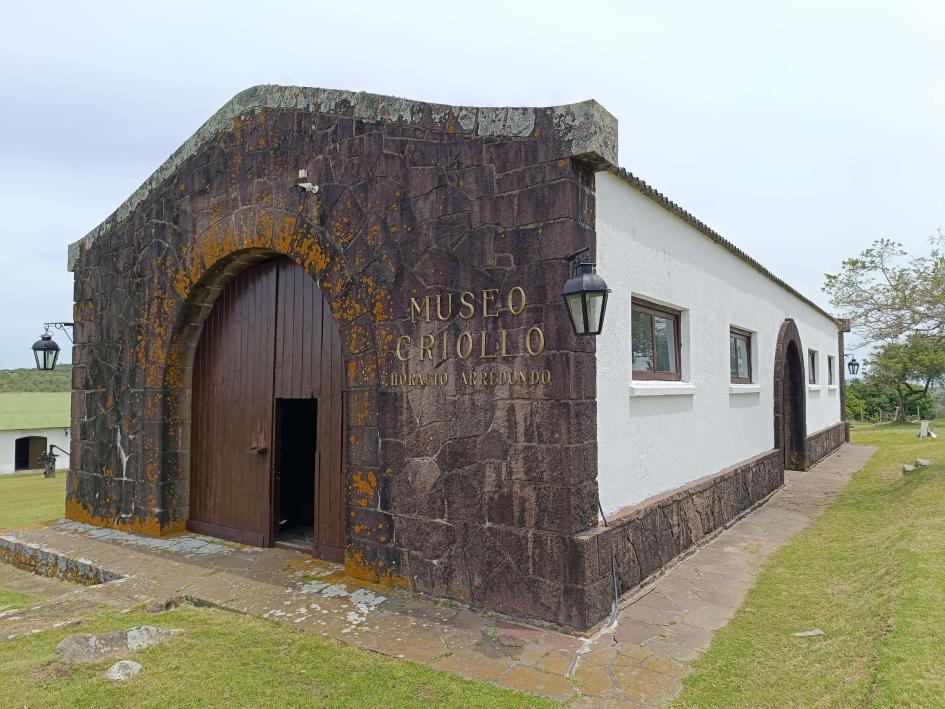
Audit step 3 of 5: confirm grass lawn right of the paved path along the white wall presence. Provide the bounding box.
[677,424,945,707]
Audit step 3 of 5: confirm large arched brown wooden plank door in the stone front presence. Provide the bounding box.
[188,258,344,558]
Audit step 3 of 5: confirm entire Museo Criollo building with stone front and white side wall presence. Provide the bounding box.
[66,86,845,629]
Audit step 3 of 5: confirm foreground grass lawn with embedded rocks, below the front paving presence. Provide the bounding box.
[0,607,554,708]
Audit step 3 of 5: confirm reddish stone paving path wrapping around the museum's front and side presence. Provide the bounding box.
[0,445,875,707]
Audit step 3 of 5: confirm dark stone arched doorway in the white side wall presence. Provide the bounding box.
[774,318,807,470]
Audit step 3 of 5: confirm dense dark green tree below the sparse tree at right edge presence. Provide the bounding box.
[860,335,945,421]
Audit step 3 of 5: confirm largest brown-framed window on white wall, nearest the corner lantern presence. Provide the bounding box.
[630,298,681,381]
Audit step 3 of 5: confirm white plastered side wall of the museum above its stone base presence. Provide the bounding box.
[596,172,842,513]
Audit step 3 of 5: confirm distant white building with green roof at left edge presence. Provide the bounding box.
[0,391,72,473]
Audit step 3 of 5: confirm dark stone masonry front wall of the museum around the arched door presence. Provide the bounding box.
[67,87,620,627]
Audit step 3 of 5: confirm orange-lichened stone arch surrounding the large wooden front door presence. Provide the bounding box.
[155,207,383,560]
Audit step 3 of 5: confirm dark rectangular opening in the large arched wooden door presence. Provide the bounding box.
[273,399,318,551]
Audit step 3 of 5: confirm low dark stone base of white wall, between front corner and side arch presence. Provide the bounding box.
[572,449,784,627]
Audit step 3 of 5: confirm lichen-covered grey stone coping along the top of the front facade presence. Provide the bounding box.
[68,84,617,271]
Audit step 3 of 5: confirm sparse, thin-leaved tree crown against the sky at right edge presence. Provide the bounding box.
[824,229,945,344]
